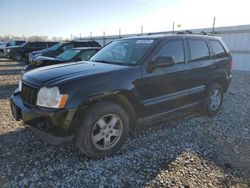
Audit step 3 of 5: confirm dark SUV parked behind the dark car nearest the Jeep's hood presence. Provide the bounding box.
[28,40,101,63]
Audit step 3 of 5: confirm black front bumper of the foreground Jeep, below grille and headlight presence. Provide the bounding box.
[10,89,76,144]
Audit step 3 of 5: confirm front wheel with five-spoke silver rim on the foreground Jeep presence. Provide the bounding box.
[76,102,129,159]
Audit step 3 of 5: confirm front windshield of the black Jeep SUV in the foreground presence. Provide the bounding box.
[90,39,154,65]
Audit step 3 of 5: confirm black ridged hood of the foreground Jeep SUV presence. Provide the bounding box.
[23,61,129,87]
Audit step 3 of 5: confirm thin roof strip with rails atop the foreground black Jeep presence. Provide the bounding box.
[124,32,220,39]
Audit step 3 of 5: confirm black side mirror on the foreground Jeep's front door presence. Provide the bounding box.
[148,56,175,72]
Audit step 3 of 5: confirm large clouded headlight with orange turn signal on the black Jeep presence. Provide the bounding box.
[36,87,68,108]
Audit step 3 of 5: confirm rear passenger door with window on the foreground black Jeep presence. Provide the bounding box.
[187,37,215,100]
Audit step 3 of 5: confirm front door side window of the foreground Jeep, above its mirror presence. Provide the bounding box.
[157,40,185,63]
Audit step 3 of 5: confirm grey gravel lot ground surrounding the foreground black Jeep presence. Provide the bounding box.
[0,59,250,188]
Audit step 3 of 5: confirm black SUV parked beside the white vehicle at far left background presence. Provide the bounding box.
[5,42,56,61]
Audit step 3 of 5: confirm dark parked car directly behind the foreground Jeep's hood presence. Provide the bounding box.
[23,47,101,73]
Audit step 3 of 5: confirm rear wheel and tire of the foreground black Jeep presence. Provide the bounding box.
[202,83,223,117]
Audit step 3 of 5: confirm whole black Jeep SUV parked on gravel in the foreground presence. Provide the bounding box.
[11,34,232,158]
